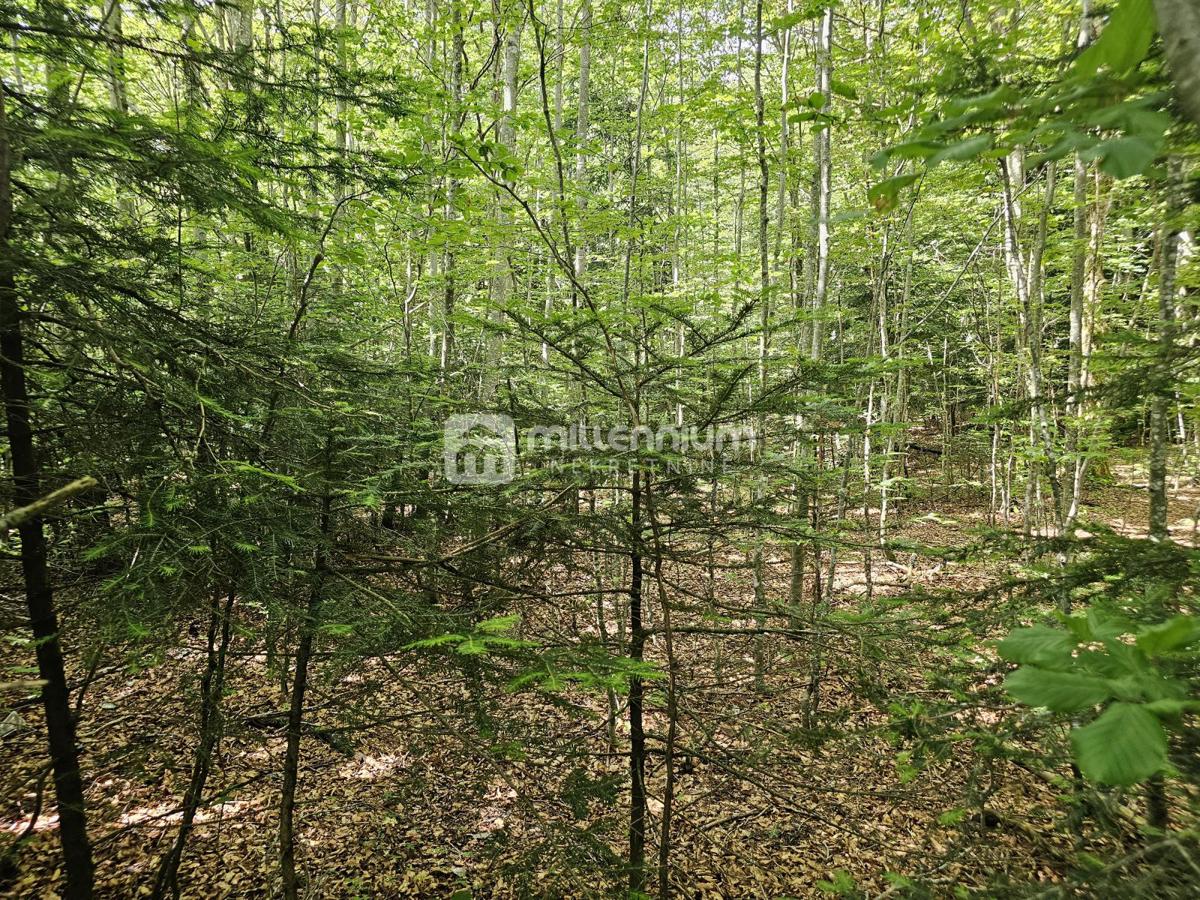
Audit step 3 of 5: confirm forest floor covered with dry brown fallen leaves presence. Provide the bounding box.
[0,460,1198,899]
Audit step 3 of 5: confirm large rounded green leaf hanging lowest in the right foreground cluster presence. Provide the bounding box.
[1070,703,1166,785]
